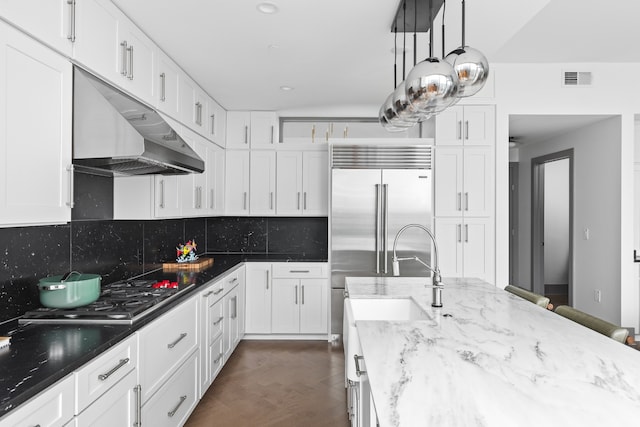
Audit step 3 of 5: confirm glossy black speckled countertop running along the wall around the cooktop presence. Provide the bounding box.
[0,254,327,417]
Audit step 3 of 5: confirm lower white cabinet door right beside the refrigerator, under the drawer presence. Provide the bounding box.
[299,279,328,334]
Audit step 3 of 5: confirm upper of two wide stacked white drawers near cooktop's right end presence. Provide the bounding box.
[138,297,199,402]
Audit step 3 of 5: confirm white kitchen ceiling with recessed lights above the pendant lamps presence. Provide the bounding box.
[113,0,640,112]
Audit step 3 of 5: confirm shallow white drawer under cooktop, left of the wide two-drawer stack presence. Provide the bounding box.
[74,336,138,415]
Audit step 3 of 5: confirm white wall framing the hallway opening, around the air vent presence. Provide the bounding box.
[491,63,640,329]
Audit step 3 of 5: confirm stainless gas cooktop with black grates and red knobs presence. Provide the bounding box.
[19,279,194,324]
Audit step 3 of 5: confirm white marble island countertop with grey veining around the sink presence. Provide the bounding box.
[346,277,640,427]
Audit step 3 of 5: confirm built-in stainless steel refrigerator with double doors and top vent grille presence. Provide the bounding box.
[330,145,433,334]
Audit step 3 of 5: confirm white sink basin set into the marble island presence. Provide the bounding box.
[350,298,431,321]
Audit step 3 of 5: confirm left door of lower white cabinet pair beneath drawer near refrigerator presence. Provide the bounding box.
[271,279,300,334]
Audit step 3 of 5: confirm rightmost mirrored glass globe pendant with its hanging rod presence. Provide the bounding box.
[445,0,489,98]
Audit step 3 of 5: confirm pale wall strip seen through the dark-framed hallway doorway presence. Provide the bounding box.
[544,159,569,285]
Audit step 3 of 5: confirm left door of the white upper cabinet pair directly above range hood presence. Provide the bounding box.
[73,0,122,83]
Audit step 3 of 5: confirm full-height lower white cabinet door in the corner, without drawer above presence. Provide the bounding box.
[245,263,273,334]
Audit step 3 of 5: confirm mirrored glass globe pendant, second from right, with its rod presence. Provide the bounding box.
[405,0,458,115]
